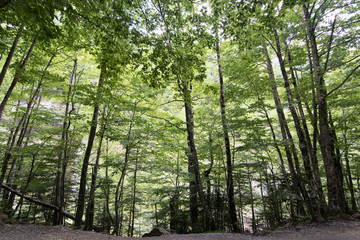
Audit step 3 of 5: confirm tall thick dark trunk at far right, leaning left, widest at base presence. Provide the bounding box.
[302,4,347,214]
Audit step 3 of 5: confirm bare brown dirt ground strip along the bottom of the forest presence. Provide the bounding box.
[0,221,360,240]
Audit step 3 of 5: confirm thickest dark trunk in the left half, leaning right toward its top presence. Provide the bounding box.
[75,63,106,229]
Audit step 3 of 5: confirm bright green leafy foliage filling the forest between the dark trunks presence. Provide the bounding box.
[0,0,360,235]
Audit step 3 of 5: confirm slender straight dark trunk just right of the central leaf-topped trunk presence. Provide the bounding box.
[216,36,239,232]
